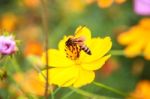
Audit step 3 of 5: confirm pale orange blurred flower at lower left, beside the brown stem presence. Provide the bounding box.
[13,70,45,96]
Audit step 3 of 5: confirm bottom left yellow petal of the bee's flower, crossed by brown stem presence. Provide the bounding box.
[40,66,79,87]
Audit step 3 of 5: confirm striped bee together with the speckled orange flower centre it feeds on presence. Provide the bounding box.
[65,27,92,59]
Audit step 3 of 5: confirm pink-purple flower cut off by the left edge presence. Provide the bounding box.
[0,36,17,55]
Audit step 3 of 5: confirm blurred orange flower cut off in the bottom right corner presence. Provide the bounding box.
[128,80,150,99]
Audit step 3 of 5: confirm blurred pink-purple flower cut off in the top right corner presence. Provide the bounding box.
[134,0,150,15]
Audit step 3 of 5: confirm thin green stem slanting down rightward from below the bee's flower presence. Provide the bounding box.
[93,82,127,96]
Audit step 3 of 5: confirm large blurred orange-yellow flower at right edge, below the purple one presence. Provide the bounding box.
[118,18,150,59]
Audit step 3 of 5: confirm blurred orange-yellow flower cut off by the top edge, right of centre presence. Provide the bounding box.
[86,0,126,8]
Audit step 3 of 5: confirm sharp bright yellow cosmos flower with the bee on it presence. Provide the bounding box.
[40,26,112,87]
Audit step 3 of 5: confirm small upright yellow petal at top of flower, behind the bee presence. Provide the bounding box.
[75,26,91,44]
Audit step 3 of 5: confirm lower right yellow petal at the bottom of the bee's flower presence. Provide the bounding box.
[73,68,95,88]
